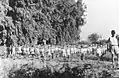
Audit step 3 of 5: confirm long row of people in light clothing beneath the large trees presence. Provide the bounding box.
[0,45,106,60]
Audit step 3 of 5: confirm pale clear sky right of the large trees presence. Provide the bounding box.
[81,0,119,40]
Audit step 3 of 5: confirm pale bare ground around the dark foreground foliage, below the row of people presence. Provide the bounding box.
[0,58,119,78]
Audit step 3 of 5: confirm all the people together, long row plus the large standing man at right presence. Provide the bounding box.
[0,30,119,68]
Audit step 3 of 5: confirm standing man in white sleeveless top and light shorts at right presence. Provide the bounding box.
[108,30,119,67]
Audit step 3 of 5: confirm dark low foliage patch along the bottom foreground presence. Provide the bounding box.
[8,64,113,78]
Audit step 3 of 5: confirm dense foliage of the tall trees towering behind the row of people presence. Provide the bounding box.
[0,0,85,45]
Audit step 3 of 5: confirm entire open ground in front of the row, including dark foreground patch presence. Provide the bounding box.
[0,54,119,78]
